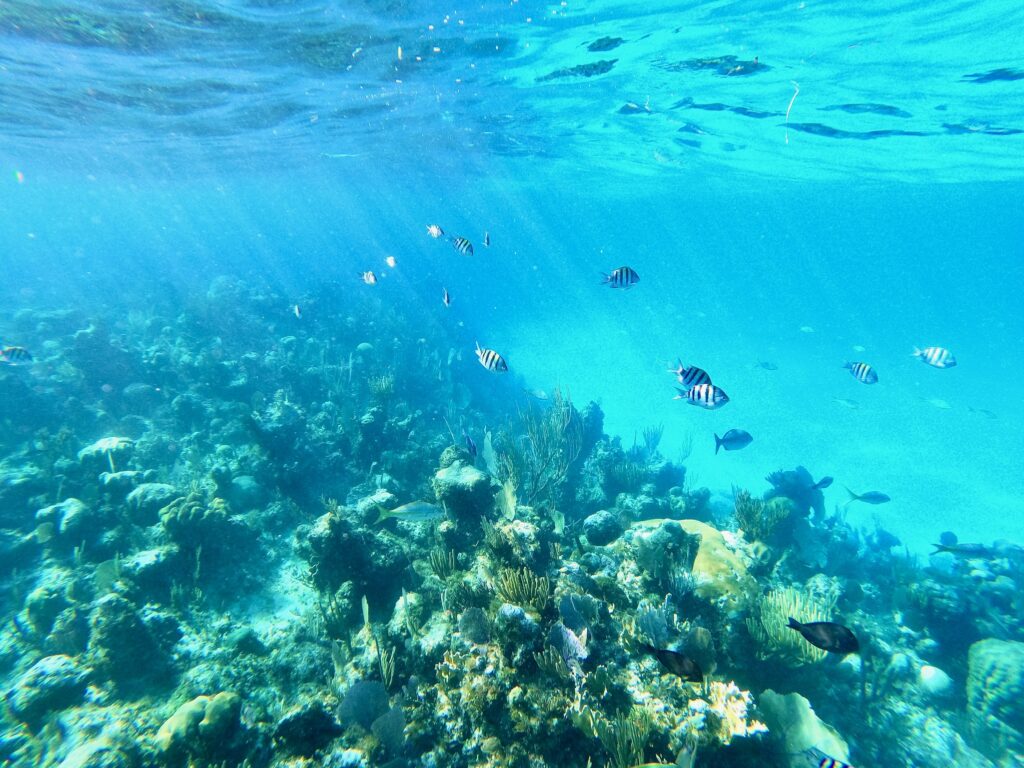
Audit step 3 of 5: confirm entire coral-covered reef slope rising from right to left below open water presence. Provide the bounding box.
[0,278,1024,768]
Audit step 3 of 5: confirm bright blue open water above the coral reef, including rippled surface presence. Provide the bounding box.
[0,0,1024,549]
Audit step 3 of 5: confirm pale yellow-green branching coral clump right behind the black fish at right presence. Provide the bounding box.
[746,587,837,667]
